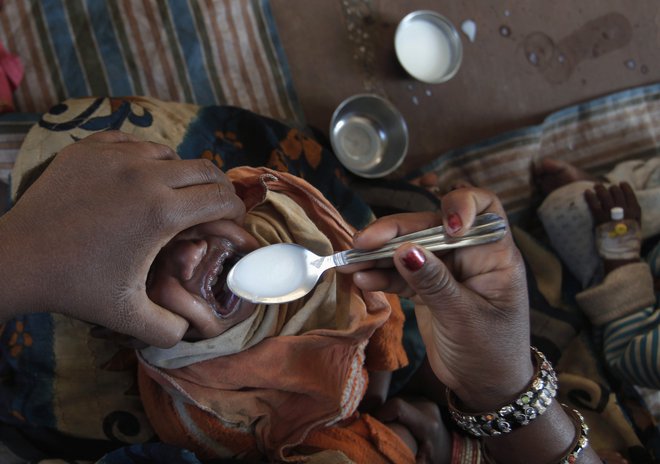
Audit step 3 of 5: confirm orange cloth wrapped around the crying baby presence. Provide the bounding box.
[140,168,414,463]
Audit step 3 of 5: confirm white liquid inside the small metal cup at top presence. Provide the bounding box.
[394,20,452,82]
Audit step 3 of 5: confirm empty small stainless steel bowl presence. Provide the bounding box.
[330,94,408,178]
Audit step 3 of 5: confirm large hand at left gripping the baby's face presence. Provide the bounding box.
[0,132,245,347]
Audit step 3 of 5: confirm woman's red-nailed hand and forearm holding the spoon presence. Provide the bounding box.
[349,188,599,463]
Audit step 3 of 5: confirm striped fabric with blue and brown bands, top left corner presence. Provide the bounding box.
[0,0,301,122]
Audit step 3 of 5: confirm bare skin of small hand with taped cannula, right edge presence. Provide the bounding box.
[584,182,642,273]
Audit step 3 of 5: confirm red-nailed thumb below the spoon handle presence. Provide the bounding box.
[394,244,461,310]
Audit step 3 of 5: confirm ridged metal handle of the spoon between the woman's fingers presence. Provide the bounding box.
[332,213,506,266]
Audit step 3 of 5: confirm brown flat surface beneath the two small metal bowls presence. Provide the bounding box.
[271,0,660,175]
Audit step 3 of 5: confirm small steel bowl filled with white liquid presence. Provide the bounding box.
[394,10,463,84]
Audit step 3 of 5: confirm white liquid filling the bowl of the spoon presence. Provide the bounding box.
[228,245,307,300]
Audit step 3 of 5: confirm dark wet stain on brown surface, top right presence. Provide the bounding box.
[523,13,632,84]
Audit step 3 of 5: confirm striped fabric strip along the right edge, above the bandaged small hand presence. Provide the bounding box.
[409,84,660,219]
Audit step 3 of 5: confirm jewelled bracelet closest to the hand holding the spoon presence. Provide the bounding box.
[447,346,557,437]
